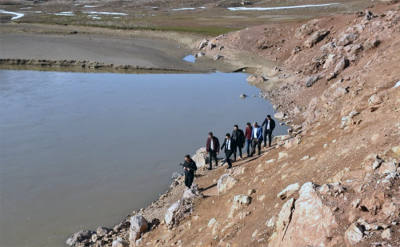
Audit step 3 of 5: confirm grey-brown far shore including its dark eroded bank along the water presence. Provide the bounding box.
[0,23,272,73]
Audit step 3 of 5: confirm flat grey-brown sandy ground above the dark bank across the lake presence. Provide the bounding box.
[0,23,250,73]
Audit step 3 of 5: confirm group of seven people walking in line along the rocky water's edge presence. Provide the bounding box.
[183,115,276,188]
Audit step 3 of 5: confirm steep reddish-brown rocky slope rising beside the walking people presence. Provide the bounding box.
[65,1,400,247]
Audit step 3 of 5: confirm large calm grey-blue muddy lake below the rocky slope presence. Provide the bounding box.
[0,70,285,247]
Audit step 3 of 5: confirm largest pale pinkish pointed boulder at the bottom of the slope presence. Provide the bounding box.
[281,182,337,246]
